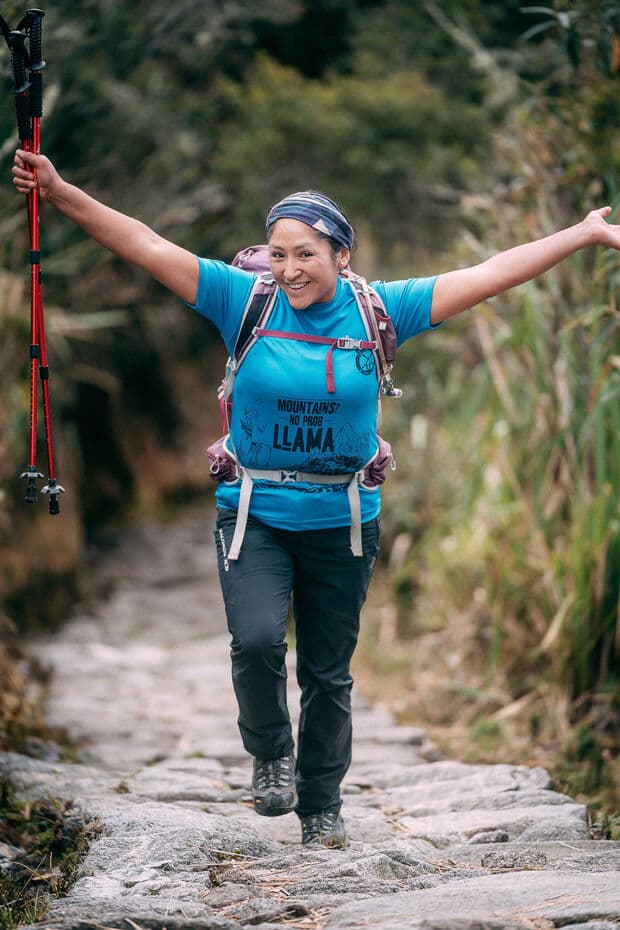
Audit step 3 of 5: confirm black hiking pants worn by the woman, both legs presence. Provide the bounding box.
[215,510,379,817]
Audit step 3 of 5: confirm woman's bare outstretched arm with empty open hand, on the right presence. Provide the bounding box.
[431,207,620,323]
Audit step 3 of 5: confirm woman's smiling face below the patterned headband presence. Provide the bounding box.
[269,218,349,310]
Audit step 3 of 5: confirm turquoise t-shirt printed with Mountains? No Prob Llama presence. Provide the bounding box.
[193,258,436,530]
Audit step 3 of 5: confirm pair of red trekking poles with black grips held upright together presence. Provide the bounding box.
[3,9,64,515]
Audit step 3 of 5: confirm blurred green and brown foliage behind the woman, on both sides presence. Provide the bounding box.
[0,0,620,835]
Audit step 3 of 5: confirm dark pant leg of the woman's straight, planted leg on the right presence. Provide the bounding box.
[293,520,379,817]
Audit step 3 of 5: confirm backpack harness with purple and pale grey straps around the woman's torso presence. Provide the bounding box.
[207,245,402,560]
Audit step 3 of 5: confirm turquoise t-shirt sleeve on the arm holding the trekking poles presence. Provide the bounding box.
[186,258,256,354]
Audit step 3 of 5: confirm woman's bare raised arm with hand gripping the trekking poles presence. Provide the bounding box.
[13,149,198,303]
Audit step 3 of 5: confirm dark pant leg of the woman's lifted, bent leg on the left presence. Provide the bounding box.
[215,510,294,760]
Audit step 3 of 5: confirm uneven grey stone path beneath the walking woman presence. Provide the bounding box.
[3,514,620,930]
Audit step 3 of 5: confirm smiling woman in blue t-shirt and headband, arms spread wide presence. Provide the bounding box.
[13,150,620,848]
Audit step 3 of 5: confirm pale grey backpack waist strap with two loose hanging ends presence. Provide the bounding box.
[228,462,364,561]
